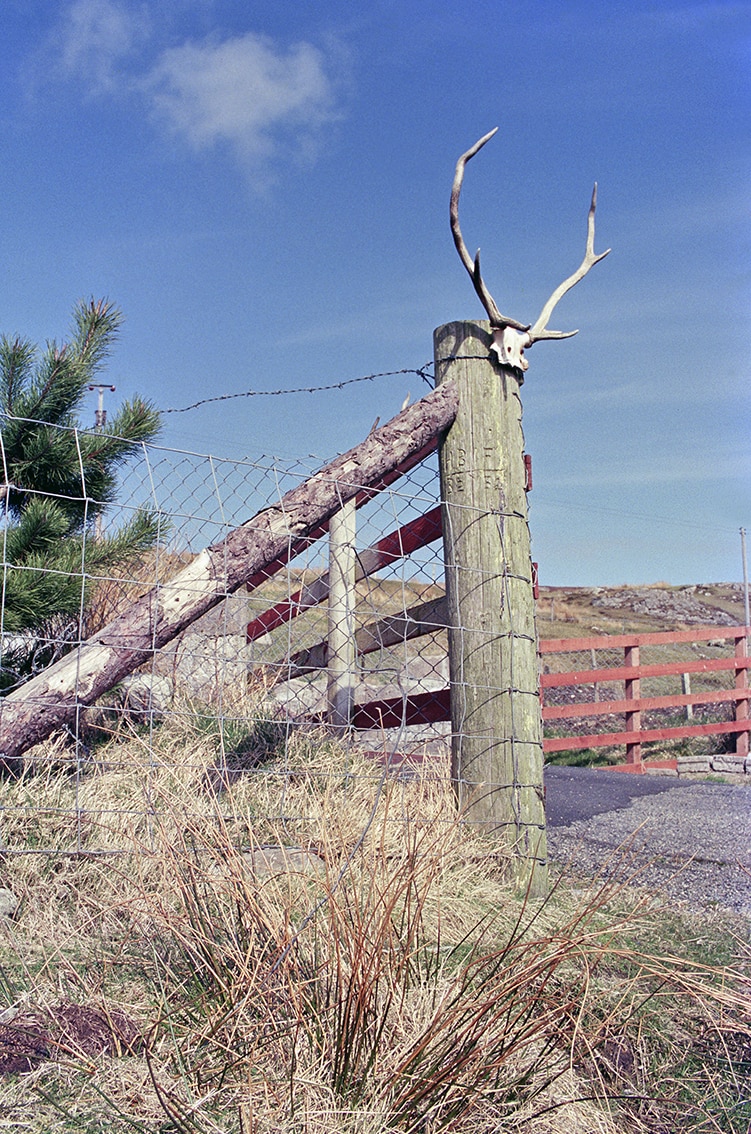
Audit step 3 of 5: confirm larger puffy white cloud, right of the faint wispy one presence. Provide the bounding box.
[147,32,335,172]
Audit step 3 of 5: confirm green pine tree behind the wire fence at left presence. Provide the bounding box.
[0,299,163,691]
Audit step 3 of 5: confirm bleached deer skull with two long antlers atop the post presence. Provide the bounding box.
[450,126,610,358]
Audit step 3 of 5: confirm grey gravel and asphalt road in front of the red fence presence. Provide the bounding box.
[546,765,751,917]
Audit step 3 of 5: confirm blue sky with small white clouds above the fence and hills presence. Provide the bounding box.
[0,0,751,585]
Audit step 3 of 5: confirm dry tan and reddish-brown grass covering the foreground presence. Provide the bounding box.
[0,703,751,1134]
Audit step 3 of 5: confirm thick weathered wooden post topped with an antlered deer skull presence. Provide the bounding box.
[442,130,609,896]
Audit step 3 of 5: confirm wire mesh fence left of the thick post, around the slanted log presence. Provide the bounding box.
[0,417,449,853]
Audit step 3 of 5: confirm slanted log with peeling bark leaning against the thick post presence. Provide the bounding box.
[0,382,458,772]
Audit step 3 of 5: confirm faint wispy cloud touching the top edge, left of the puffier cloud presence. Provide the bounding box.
[55,0,147,93]
